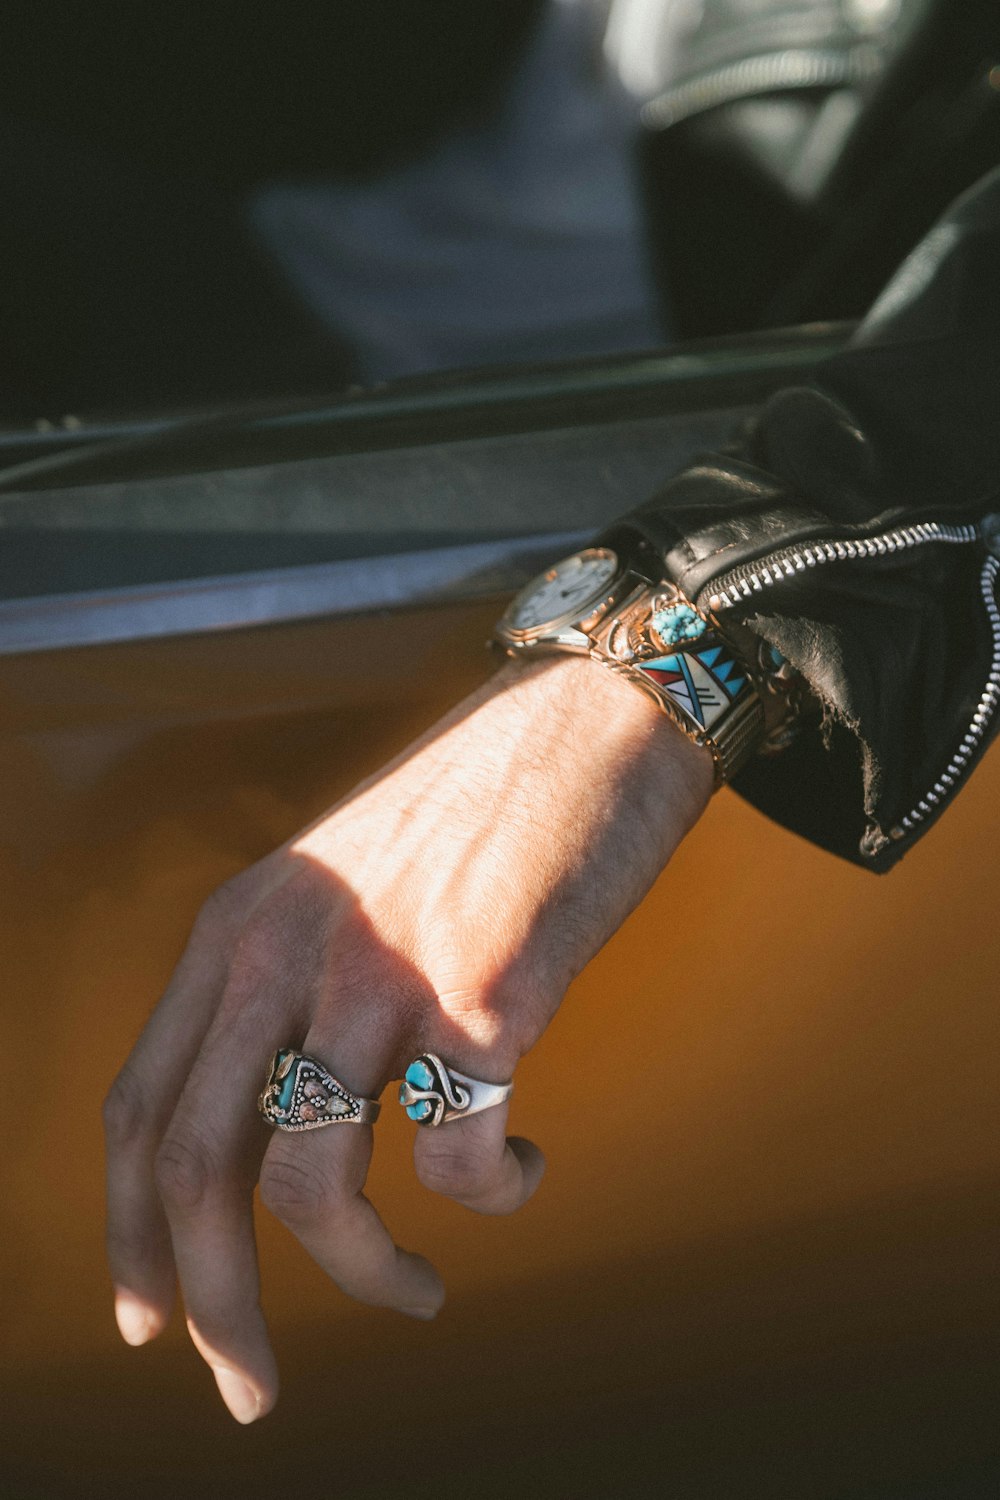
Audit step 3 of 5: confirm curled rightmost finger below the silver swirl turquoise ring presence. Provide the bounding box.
[414,1103,546,1214]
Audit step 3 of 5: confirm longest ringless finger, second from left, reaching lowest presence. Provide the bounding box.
[156,966,301,1422]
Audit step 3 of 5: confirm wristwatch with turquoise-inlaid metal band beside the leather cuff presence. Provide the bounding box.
[495,546,795,786]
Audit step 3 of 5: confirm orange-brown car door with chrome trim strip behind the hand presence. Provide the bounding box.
[0,327,1000,1497]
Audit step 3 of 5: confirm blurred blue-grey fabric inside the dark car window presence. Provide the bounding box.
[247,0,666,381]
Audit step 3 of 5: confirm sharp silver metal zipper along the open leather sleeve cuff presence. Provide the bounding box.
[697,516,1000,858]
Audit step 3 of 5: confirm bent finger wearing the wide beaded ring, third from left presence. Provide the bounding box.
[261,1023,444,1319]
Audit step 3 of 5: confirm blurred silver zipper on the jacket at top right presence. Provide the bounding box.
[642,47,879,131]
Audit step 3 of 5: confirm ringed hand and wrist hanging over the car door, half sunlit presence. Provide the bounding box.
[105,657,712,1422]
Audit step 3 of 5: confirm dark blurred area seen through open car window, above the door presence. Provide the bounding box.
[0,0,1000,420]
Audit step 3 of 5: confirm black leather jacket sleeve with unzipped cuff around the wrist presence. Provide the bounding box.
[603,171,1000,872]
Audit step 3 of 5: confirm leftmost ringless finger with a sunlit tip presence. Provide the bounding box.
[103,909,236,1344]
